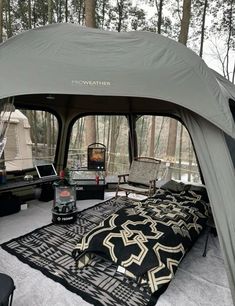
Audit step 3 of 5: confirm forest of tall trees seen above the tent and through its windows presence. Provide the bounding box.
[0,0,235,180]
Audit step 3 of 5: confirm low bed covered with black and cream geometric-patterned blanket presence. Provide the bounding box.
[72,187,208,295]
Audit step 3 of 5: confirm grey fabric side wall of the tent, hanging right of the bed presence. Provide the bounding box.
[182,112,235,301]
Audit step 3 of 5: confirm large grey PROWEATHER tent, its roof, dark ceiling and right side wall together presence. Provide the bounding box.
[0,24,235,302]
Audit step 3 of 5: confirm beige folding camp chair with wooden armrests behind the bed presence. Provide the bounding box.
[116,157,161,197]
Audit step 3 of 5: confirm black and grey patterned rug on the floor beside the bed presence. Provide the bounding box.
[1,198,157,306]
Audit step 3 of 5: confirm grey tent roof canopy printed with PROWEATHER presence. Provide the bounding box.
[0,24,235,136]
